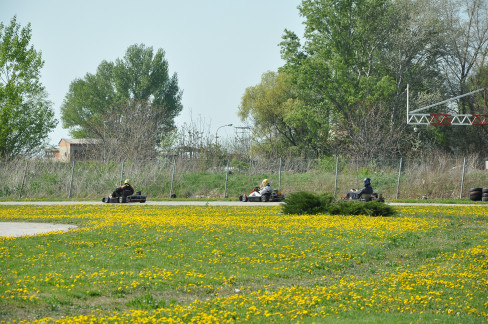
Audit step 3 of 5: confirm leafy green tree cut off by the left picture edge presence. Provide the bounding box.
[0,17,57,158]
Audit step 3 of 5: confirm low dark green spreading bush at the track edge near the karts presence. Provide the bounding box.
[282,191,395,216]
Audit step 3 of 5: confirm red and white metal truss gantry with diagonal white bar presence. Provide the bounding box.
[407,85,488,126]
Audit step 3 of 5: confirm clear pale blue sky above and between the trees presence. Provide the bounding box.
[0,0,303,145]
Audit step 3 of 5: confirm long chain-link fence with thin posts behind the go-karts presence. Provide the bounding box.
[0,156,488,199]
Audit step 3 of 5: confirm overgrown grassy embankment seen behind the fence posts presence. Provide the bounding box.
[0,157,488,201]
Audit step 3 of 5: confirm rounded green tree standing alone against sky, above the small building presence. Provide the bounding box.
[61,44,183,147]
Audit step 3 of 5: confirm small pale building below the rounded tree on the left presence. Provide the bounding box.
[45,138,103,162]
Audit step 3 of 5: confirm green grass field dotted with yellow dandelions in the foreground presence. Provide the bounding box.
[0,205,488,323]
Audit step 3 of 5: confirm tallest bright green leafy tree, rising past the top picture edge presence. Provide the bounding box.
[280,0,402,154]
